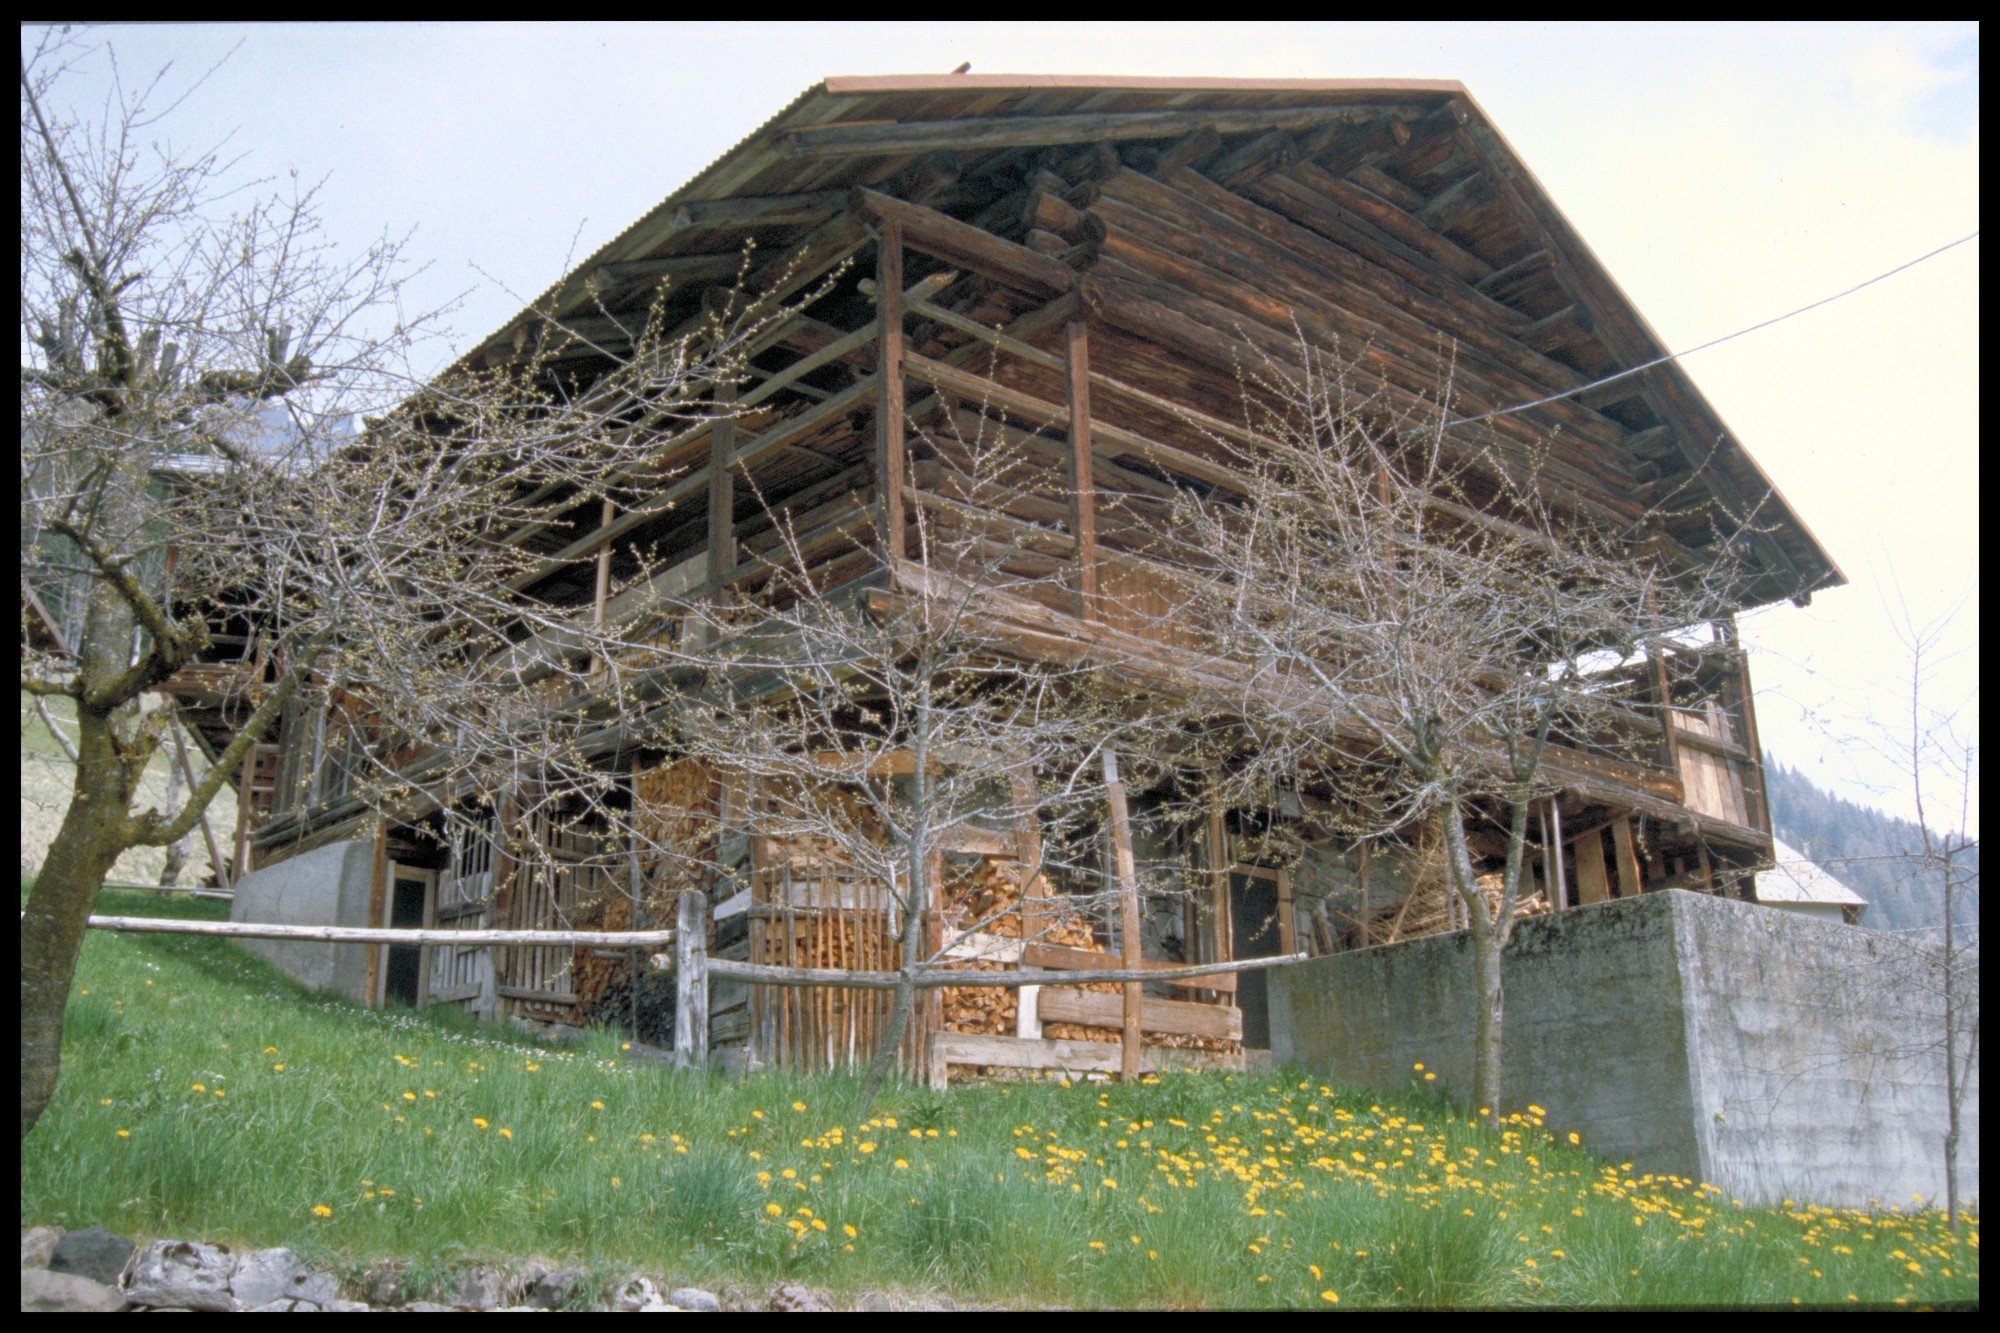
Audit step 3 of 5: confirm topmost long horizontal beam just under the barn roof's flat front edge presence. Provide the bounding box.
[784,104,1394,158]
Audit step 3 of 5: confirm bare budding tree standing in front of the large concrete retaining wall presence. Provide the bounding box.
[1180,340,1728,1115]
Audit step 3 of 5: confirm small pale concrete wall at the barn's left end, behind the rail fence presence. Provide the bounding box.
[230,839,382,1005]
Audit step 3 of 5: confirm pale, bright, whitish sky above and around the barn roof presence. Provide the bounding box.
[24,22,1980,829]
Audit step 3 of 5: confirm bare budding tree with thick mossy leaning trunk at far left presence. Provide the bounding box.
[20,36,796,1137]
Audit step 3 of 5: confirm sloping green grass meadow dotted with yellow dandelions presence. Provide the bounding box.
[22,893,1978,1309]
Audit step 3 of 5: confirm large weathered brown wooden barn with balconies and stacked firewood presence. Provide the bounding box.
[207,74,1842,1079]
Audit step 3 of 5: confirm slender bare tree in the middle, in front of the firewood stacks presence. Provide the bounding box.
[672,390,1122,1099]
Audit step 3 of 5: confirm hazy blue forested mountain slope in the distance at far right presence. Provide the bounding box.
[1764,755,1980,941]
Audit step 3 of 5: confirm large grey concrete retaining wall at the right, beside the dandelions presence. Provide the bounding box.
[1272,891,1978,1205]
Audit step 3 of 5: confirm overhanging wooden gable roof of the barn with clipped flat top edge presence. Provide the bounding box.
[468,74,1846,602]
